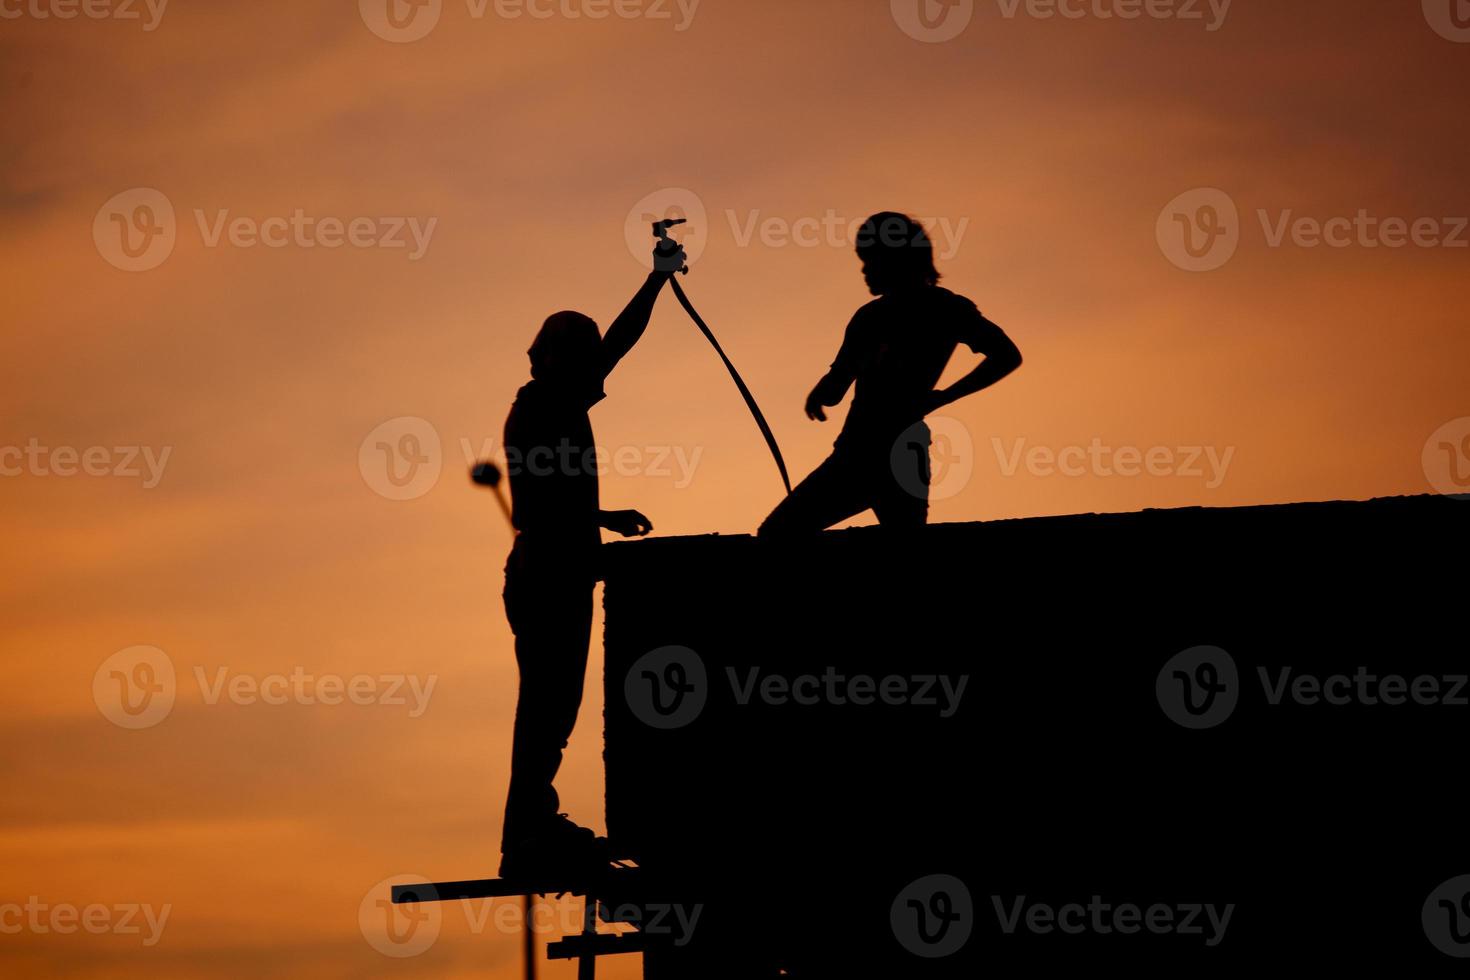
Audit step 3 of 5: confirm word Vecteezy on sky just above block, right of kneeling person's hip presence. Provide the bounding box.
[991,436,1235,489]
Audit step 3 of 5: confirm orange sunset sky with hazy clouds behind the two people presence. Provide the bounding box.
[0,0,1470,977]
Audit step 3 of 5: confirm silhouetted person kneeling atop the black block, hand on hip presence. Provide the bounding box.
[760,212,1022,538]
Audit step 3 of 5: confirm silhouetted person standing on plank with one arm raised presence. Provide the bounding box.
[500,235,685,877]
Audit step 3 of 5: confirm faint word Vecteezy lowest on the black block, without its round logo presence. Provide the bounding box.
[991,895,1235,948]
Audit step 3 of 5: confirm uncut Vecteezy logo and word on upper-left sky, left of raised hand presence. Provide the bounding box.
[93,187,440,272]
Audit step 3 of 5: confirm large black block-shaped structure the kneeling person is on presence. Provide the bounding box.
[606,497,1470,979]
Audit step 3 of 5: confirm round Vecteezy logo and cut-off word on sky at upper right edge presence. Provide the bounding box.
[1155,188,1470,272]
